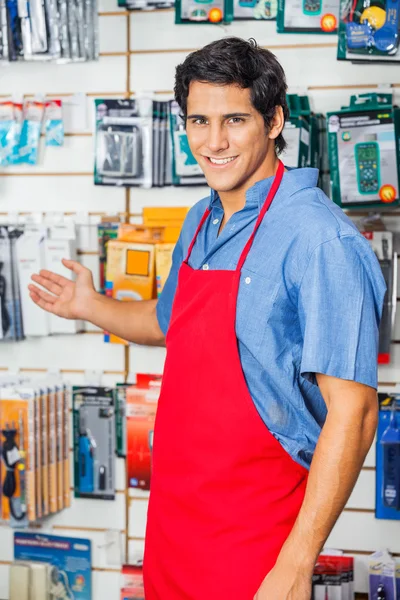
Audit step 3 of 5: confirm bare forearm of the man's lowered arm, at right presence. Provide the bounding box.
[281,397,377,570]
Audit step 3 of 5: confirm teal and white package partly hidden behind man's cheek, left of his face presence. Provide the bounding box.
[170,100,206,186]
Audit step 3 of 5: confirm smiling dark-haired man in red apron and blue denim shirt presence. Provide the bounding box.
[30,38,385,600]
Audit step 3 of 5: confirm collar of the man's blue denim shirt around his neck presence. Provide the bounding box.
[209,167,318,211]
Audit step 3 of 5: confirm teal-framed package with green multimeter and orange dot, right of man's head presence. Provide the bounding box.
[327,93,400,208]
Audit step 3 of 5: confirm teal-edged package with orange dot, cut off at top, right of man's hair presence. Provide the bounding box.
[277,0,340,34]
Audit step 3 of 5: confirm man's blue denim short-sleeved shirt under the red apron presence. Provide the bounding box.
[157,169,386,468]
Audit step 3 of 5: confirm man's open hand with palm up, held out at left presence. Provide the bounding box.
[29,261,95,319]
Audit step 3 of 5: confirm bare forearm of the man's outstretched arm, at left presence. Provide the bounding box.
[83,293,165,346]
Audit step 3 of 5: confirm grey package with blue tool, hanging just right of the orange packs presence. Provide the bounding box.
[72,386,115,500]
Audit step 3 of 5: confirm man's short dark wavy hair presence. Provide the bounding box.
[174,37,289,154]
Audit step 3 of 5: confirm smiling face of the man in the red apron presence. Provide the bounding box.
[186,81,276,192]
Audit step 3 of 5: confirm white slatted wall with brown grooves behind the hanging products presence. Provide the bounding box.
[0,0,400,600]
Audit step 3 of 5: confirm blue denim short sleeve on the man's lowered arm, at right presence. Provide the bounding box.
[298,234,386,388]
